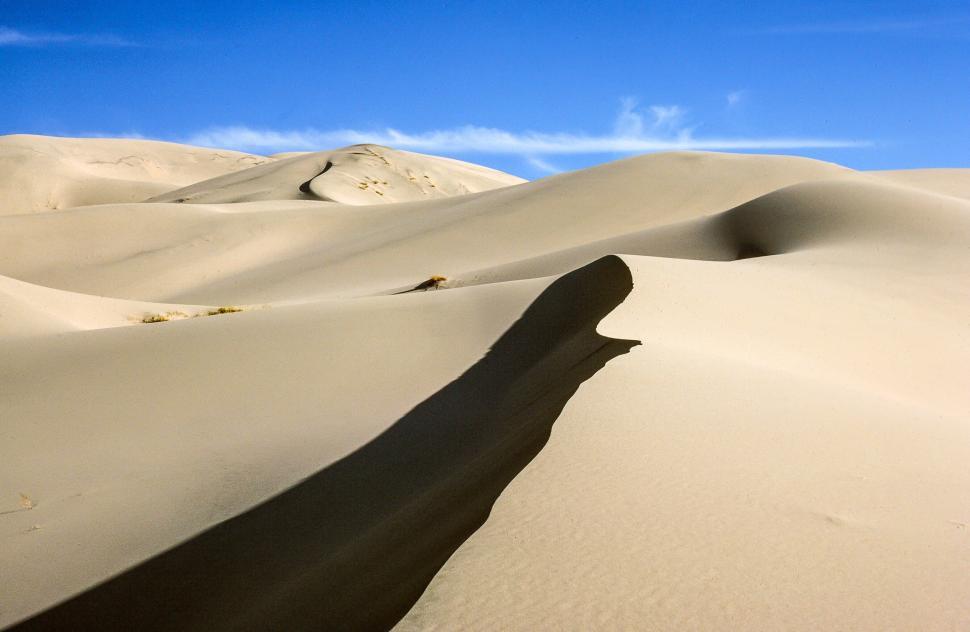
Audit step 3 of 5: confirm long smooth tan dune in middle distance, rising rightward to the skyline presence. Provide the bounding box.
[0,153,851,303]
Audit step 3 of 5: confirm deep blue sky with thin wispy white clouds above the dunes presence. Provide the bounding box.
[0,0,970,177]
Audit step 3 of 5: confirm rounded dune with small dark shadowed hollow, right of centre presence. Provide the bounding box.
[449,178,970,287]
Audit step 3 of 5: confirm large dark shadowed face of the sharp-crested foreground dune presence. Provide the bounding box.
[14,256,639,630]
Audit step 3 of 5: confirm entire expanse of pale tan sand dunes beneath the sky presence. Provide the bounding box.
[0,136,970,630]
